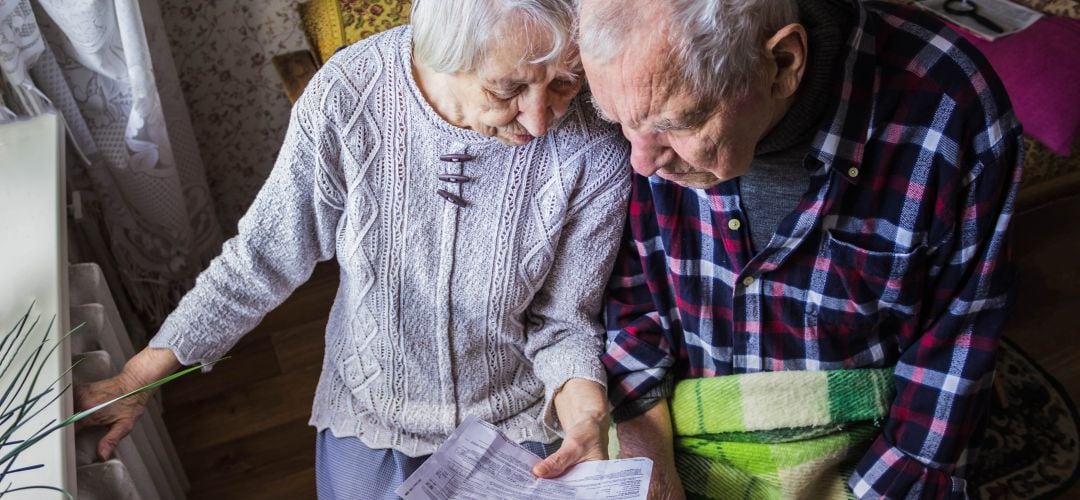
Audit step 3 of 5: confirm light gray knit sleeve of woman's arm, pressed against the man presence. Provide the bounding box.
[525,135,630,430]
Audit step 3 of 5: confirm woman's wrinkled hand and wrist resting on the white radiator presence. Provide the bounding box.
[75,348,180,461]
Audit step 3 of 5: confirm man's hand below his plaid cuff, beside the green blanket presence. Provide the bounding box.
[616,400,686,500]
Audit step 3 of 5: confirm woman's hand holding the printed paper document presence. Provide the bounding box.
[532,378,609,478]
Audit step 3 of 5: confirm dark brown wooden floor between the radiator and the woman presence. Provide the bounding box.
[163,265,338,500]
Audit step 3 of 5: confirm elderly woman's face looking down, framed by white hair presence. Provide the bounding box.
[450,30,583,146]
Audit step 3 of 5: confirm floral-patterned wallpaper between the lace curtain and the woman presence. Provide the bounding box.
[161,0,307,235]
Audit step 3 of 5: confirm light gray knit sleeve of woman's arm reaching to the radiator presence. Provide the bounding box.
[149,71,343,365]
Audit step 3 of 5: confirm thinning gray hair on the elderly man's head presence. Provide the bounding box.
[579,0,798,102]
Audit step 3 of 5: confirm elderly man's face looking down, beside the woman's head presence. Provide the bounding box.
[582,2,775,188]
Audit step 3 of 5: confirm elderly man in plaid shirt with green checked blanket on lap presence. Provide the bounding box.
[580,0,1022,498]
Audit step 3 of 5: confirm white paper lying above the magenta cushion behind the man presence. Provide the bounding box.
[915,0,1042,41]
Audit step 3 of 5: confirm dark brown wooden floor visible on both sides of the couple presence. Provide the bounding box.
[164,197,1080,500]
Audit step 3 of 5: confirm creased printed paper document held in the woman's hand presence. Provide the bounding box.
[396,417,652,500]
